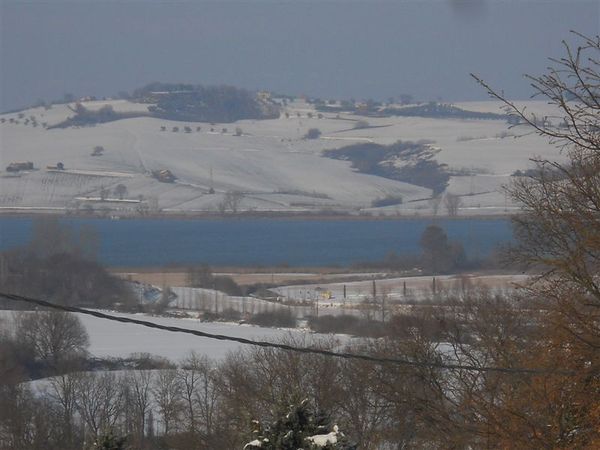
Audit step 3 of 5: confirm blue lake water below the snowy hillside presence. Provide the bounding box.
[0,217,512,266]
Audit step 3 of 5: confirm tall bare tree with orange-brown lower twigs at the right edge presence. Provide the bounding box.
[468,33,600,448]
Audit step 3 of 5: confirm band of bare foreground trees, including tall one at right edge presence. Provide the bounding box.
[0,36,600,450]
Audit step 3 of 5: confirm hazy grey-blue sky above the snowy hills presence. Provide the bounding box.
[0,0,600,110]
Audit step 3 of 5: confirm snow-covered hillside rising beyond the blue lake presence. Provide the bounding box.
[0,100,560,215]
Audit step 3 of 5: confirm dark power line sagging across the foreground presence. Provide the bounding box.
[0,292,574,376]
